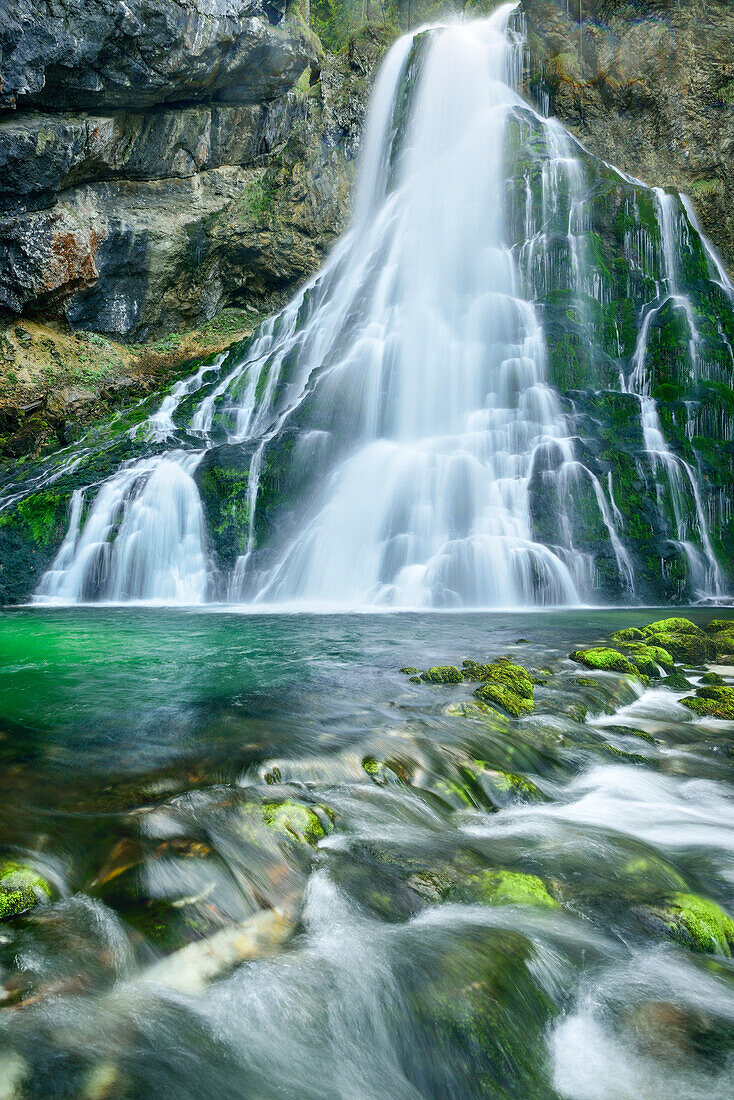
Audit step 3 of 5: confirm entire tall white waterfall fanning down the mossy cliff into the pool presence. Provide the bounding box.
[31,4,728,607]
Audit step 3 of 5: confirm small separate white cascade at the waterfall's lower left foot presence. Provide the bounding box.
[36,452,208,604]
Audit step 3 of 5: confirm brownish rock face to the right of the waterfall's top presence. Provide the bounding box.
[523,0,734,268]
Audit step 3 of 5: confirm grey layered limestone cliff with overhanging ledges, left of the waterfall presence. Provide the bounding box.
[0,0,336,339]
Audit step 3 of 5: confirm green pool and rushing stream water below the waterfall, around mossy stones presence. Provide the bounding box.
[0,608,734,1100]
